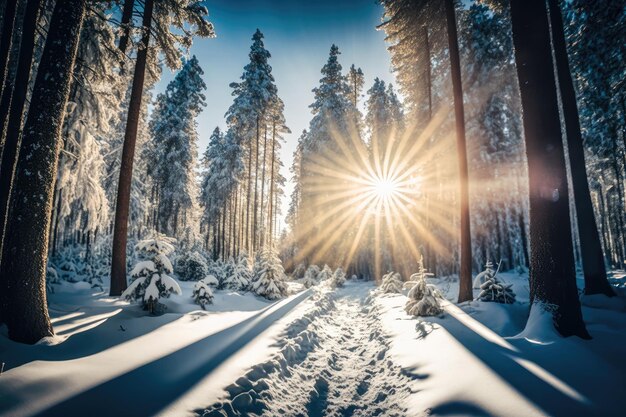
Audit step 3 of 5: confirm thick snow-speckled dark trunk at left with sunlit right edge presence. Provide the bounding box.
[0,0,86,344]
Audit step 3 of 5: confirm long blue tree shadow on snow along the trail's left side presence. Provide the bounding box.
[30,291,310,417]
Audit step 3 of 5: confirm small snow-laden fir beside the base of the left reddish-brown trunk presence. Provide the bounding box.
[122,236,182,314]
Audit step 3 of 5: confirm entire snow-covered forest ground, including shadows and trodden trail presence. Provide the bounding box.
[0,273,626,417]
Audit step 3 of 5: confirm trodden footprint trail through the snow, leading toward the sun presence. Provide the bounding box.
[198,283,412,417]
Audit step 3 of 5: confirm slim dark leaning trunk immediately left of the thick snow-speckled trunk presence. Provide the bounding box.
[0,0,41,261]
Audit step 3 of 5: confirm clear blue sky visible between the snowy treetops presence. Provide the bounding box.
[156,0,393,231]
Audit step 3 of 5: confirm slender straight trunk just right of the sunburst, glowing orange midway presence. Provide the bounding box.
[444,0,474,303]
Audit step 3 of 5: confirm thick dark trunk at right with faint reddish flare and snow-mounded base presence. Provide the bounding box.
[511,0,590,339]
